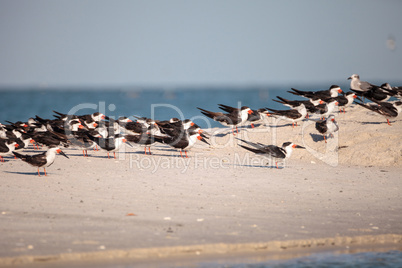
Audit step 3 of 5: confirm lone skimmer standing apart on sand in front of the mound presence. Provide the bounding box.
[238,139,305,168]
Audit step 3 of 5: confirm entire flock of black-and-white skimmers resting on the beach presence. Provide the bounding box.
[0,74,402,176]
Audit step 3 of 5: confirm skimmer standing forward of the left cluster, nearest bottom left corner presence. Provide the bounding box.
[13,147,68,176]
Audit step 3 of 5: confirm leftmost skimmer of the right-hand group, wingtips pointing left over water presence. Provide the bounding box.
[197,104,253,135]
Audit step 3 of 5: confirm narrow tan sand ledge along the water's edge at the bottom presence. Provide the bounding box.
[0,234,402,267]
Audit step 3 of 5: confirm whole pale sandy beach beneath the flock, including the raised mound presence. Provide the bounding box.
[0,104,402,266]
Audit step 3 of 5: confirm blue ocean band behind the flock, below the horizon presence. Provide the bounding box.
[0,86,348,128]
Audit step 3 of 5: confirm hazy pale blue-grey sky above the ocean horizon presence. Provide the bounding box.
[0,0,402,87]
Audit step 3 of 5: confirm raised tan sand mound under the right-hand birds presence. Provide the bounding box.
[204,106,402,166]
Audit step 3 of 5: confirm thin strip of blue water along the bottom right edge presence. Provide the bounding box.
[196,250,402,268]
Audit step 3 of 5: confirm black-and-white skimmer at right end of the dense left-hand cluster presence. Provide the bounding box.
[154,131,209,157]
